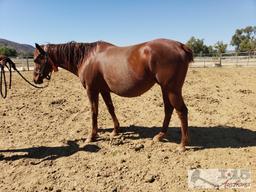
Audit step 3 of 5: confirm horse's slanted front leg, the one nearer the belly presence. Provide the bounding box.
[101,92,120,139]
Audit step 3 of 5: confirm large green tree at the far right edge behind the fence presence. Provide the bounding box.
[230,26,256,51]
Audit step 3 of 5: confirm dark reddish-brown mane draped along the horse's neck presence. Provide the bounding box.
[45,41,105,73]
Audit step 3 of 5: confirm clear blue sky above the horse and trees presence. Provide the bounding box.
[0,0,256,46]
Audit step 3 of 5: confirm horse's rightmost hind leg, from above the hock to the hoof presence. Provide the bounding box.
[168,91,189,151]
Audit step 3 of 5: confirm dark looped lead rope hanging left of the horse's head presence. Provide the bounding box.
[0,59,49,99]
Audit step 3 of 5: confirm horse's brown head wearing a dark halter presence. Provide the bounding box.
[34,43,57,84]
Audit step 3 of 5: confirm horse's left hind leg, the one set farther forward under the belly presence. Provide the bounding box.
[153,86,173,141]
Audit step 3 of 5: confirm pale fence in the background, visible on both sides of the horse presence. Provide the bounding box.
[8,51,256,71]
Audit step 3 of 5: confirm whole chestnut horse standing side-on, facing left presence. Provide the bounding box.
[33,39,193,151]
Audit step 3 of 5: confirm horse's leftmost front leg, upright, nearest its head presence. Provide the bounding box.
[86,87,99,142]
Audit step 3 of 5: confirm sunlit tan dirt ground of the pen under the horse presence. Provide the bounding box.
[0,68,256,192]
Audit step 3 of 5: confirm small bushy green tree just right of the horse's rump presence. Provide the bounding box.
[186,37,209,55]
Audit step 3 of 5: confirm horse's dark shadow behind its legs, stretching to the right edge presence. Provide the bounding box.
[103,125,256,149]
